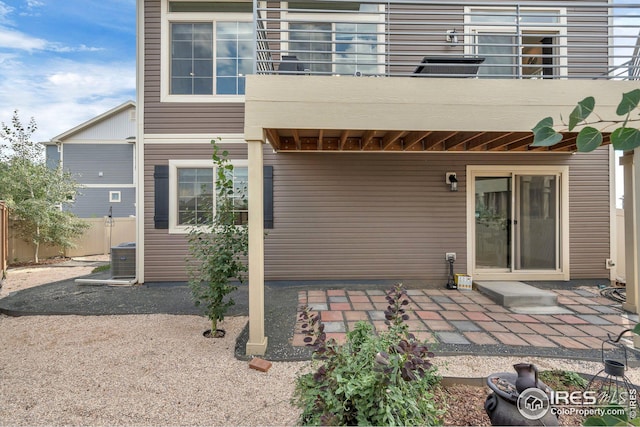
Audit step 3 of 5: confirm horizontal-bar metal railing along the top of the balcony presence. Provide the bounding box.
[254,0,640,79]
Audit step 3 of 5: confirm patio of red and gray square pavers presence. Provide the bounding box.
[293,287,638,357]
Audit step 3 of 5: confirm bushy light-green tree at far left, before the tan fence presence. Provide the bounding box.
[0,111,88,263]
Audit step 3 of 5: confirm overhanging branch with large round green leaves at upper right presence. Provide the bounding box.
[531,89,640,152]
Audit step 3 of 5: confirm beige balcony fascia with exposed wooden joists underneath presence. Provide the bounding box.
[245,75,637,152]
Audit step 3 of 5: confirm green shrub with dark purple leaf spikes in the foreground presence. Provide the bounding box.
[293,284,443,426]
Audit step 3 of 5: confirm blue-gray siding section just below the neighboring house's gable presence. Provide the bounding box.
[63,144,134,184]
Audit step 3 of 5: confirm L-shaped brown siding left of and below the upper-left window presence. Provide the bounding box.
[144,0,244,134]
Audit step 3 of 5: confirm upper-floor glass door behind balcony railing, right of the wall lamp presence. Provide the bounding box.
[465,8,566,79]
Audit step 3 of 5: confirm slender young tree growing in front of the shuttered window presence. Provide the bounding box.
[187,141,249,334]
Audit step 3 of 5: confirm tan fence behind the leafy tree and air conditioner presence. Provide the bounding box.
[6,217,136,263]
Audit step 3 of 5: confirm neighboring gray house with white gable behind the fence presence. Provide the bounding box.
[44,101,136,218]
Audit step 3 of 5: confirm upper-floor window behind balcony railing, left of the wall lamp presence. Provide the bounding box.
[283,1,384,74]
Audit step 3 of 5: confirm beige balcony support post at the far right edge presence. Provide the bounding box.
[620,149,640,313]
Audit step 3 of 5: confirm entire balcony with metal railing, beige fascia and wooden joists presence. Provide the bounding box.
[245,0,640,153]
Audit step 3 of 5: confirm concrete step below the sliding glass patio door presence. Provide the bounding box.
[474,280,558,307]
